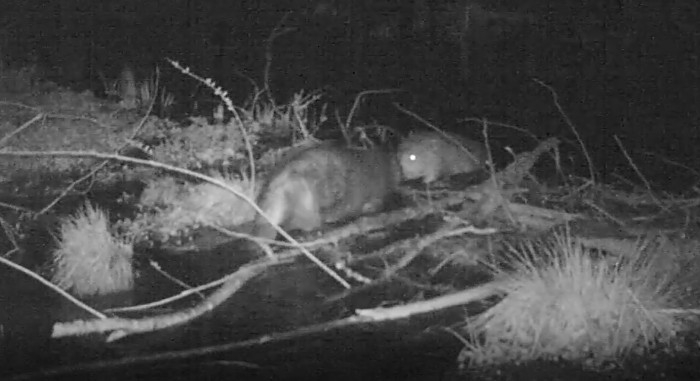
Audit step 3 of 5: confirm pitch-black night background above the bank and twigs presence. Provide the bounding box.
[0,0,700,190]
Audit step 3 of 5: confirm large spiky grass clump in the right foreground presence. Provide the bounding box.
[460,229,683,367]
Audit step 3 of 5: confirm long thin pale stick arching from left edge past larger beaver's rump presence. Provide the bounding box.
[0,151,350,288]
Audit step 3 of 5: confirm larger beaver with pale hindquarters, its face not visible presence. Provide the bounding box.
[253,143,401,239]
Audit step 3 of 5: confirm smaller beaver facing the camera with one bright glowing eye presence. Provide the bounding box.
[398,131,488,184]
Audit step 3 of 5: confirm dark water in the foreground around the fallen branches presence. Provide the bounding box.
[2,236,468,380]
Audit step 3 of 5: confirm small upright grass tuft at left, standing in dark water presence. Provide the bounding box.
[52,203,134,296]
